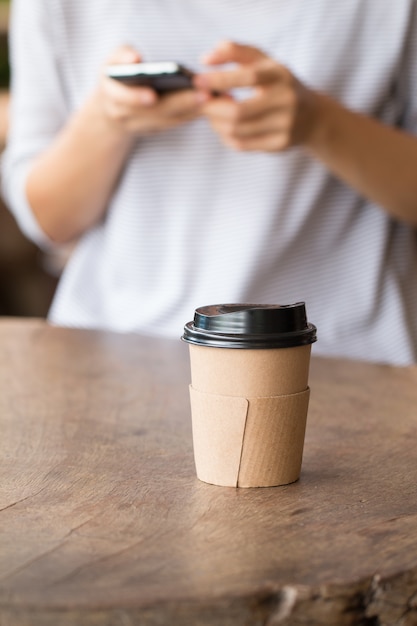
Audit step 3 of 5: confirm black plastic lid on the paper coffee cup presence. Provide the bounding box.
[182,302,317,348]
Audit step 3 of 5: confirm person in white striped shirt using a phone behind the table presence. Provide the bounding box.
[3,0,417,364]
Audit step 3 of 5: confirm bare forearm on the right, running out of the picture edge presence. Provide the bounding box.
[305,94,417,225]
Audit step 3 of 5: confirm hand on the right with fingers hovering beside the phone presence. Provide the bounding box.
[194,42,315,152]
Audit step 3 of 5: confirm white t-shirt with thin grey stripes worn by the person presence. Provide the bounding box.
[3,0,417,364]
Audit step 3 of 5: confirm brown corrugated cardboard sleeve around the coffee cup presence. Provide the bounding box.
[190,385,310,487]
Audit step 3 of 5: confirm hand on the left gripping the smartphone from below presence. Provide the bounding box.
[95,46,210,136]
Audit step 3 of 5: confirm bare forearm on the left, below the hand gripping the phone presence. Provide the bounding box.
[26,88,132,243]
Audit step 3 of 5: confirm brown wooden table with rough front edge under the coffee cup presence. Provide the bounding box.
[0,318,417,626]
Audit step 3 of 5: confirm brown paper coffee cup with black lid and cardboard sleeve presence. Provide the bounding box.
[182,302,316,487]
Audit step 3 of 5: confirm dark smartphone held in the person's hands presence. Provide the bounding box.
[106,61,194,93]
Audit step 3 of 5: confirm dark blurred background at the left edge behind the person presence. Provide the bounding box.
[0,0,62,317]
